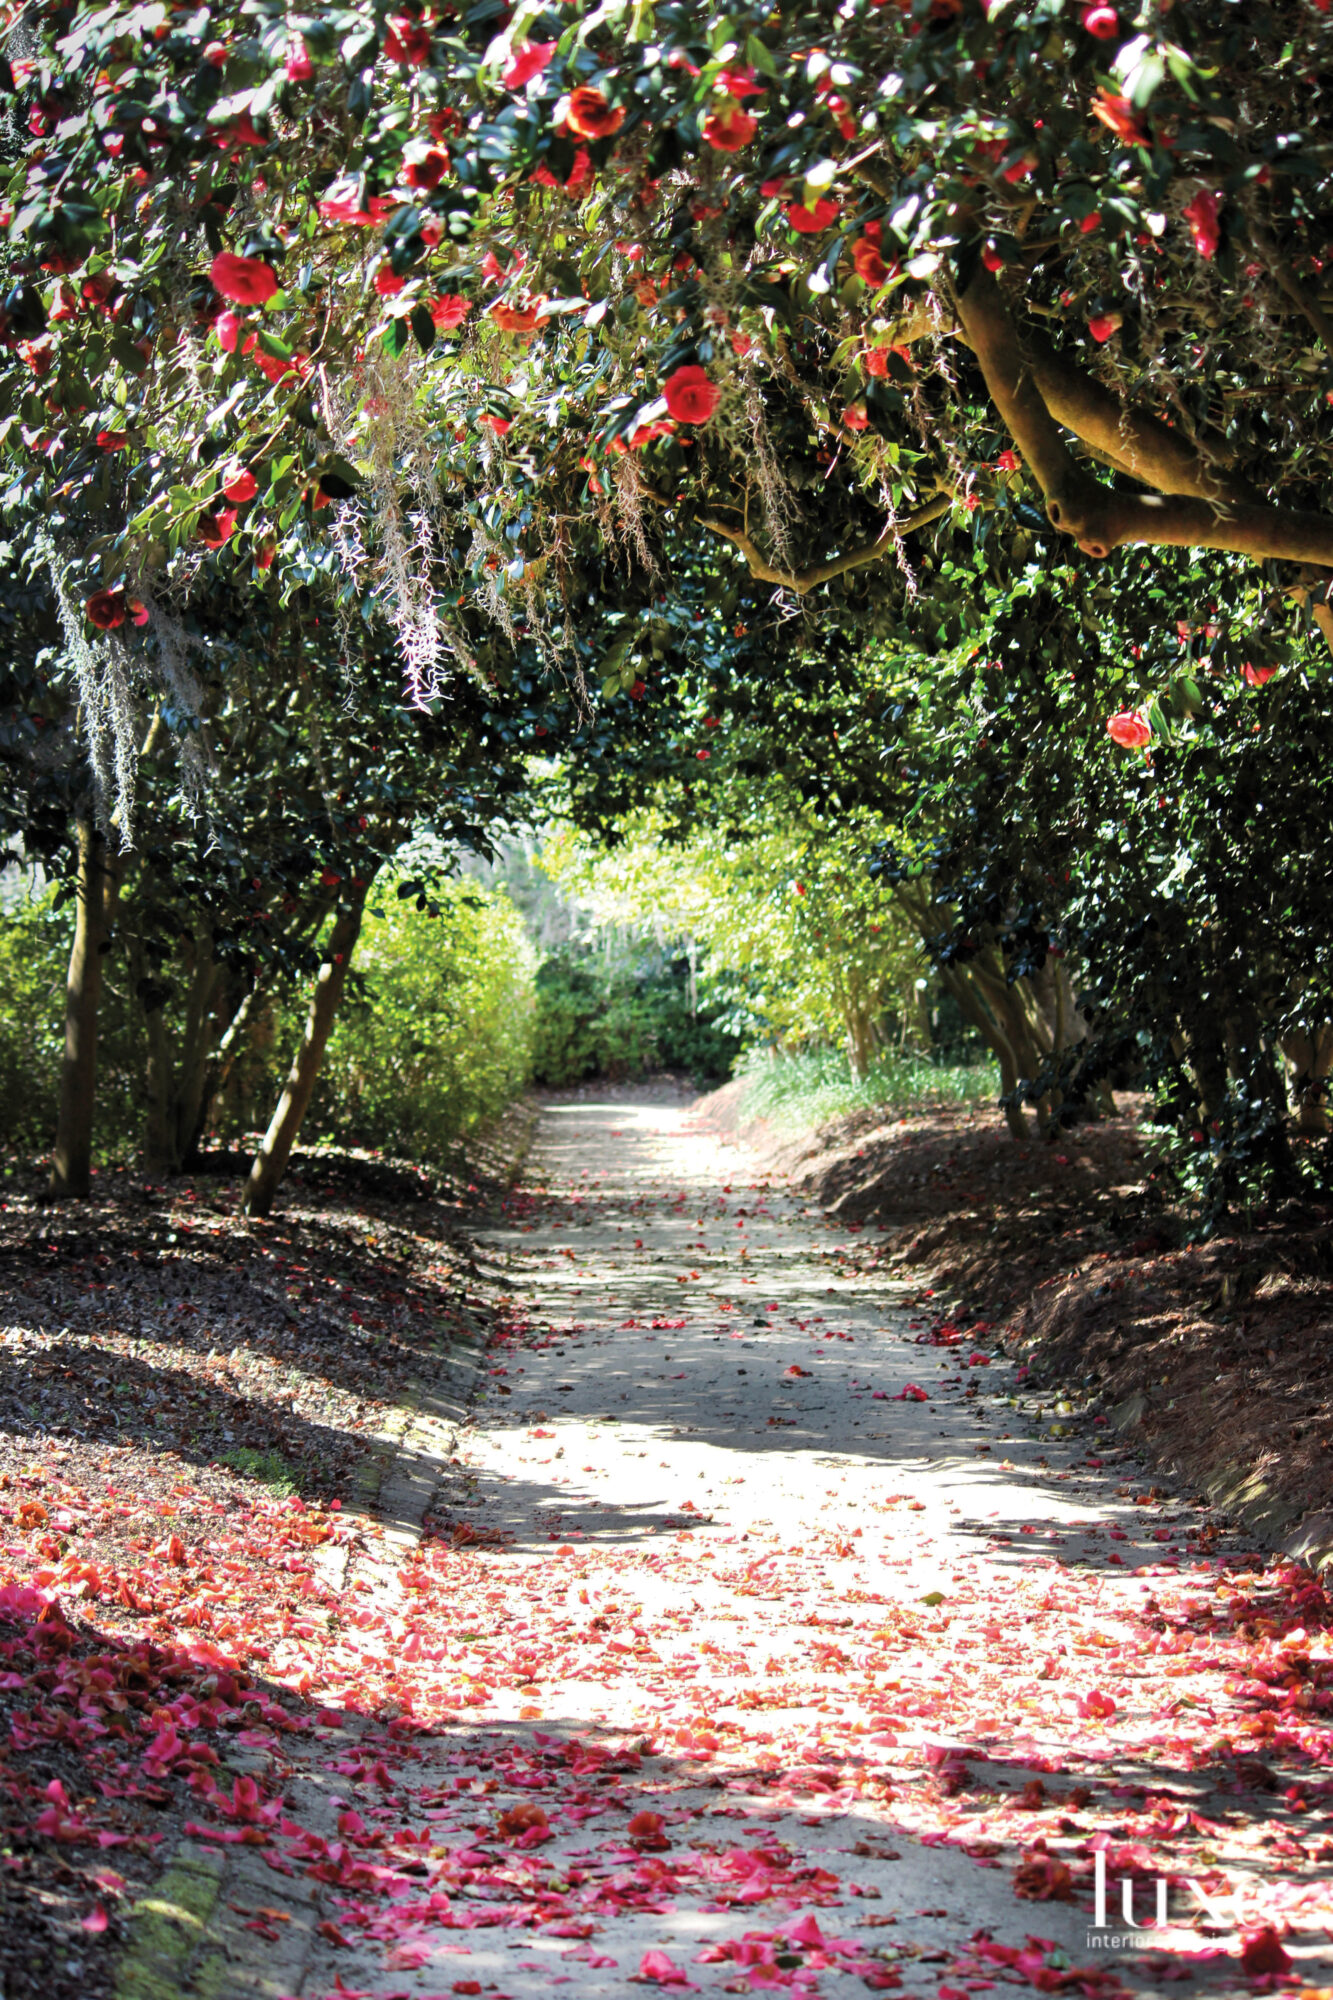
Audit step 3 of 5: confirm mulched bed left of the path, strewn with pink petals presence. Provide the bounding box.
[0,1154,504,2000]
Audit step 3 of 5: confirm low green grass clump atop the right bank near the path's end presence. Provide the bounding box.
[737,1048,999,1130]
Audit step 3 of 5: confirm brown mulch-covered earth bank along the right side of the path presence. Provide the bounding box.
[697,1084,1333,1564]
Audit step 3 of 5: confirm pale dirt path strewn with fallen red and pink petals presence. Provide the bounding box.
[290,1094,1333,2000]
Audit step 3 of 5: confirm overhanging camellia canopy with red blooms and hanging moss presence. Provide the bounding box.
[2,0,1333,698]
